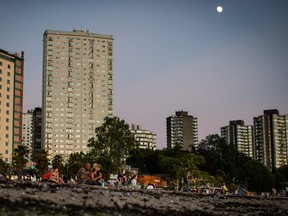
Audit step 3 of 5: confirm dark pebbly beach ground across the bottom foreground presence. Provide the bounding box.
[0,182,288,216]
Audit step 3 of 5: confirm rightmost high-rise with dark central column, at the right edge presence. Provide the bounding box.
[253,109,288,171]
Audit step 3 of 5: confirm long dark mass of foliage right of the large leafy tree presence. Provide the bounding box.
[127,134,276,193]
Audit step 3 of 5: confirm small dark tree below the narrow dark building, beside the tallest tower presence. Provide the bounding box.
[33,149,49,177]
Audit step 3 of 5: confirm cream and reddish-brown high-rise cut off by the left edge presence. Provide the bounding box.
[0,49,24,163]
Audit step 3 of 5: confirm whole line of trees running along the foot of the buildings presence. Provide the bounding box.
[0,117,288,193]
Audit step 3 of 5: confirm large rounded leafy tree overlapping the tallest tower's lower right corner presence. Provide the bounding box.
[88,117,138,173]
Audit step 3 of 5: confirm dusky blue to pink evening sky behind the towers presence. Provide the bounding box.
[0,0,288,149]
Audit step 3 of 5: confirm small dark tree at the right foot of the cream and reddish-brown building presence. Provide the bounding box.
[12,145,29,177]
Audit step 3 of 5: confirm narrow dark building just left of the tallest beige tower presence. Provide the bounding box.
[32,107,42,154]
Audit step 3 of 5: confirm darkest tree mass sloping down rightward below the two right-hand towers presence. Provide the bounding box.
[198,134,274,193]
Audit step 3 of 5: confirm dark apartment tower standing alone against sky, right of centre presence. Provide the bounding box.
[166,111,198,150]
